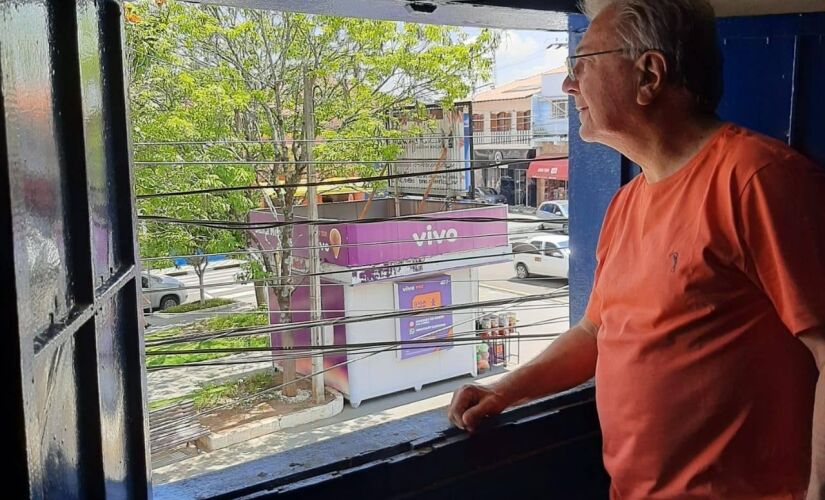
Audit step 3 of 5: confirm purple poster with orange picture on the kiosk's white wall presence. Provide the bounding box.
[395,274,453,359]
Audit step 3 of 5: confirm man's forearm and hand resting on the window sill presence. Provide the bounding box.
[448,319,598,432]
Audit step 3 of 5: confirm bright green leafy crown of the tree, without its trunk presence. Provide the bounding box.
[122,0,499,229]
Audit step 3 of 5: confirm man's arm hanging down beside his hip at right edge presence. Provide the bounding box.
[799,328,825,500]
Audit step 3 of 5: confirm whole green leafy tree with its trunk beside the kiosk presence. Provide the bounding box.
[127,1,498,394]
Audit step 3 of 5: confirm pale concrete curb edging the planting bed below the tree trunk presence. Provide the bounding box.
[196,387,344,451]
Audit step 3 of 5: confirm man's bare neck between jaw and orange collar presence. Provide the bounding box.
[617,116,722,183]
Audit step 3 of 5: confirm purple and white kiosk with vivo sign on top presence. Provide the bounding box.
[249,199,512,407]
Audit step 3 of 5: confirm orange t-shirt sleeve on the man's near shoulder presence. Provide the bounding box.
[738,155,825,335]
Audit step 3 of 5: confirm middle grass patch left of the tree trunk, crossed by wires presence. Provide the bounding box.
[146,312,269,368]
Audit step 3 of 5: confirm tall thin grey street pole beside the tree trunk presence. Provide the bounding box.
[304,66,324,404]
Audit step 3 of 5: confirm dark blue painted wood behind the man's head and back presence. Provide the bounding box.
[718,14,825,165]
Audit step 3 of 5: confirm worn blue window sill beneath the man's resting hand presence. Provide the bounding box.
[154,382,601,499]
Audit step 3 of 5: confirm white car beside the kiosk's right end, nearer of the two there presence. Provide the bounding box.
[513,234,570,279]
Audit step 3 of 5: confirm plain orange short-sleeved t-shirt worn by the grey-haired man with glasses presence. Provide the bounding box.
[585,124,825,499]
